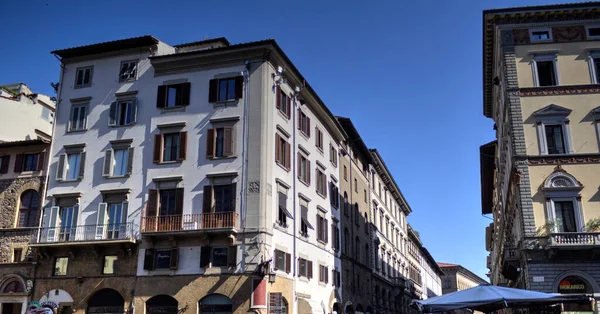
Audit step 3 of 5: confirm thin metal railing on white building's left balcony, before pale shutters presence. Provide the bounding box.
[38,222,137,243]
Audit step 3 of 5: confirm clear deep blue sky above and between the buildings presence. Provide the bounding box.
[0,0,580,279]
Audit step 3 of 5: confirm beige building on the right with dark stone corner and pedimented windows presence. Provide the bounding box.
[480,2,600,310]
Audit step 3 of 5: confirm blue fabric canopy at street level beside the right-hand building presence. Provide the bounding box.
[414,284,590,313]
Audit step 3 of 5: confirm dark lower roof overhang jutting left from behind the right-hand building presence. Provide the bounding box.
[479,141,498,215]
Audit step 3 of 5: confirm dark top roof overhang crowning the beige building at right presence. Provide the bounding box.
[483,2,600,118]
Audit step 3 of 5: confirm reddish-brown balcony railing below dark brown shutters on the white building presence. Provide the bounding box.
[142,212,238,232]
